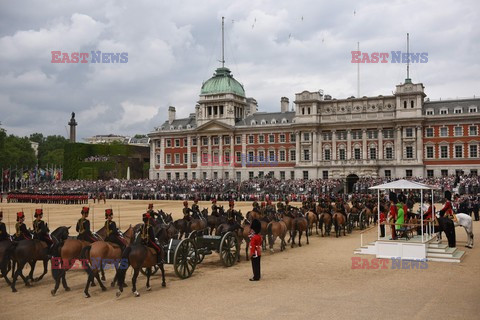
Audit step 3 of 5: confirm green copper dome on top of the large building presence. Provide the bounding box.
[200,67,245,97]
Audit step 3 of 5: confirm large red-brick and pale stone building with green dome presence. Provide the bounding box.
[149,68,480,188]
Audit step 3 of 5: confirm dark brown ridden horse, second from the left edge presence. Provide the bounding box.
[11,227,70,292]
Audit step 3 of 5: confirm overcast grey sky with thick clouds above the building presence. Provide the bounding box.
[0,0,480,139]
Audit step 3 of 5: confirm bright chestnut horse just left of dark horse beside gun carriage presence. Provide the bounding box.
[81,226,133,298]
